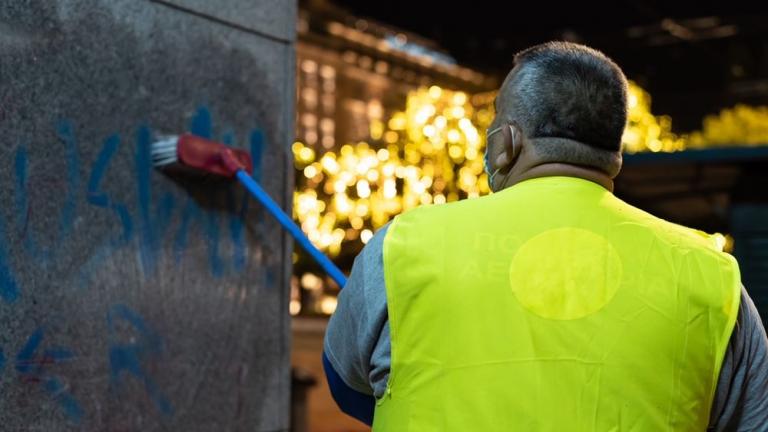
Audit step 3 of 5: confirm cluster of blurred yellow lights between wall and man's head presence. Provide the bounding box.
[292,86,493,256]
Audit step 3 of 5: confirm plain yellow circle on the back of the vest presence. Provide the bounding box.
[509,228,622,320]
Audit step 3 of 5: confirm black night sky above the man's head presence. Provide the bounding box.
[333,0,768,131]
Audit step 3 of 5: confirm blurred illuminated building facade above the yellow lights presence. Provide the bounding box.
[296,1,497,153]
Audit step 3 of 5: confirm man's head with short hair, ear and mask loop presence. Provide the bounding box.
[487,42,627,188]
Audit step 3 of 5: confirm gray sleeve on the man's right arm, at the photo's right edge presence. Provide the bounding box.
[709,287,768,432]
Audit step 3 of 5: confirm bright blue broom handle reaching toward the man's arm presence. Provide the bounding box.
[231,170,347,288]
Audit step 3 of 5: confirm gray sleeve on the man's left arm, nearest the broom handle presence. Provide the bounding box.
[323,225,390,397]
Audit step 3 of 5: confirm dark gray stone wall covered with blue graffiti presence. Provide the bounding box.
[0,0,296,431]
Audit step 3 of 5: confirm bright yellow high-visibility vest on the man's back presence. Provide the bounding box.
[373,177,741,432]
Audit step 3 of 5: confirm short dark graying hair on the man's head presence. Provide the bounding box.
[499,42,627,152]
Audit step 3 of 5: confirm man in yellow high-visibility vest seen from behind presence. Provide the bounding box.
[323,42,768,432]
